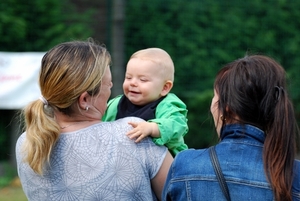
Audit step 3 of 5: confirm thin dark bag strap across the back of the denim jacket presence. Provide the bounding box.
[208,146,231,201]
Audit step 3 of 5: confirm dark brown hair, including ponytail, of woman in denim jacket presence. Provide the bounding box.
[214,55,299,200]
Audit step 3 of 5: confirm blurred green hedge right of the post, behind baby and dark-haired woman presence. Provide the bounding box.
[125,0,300,147]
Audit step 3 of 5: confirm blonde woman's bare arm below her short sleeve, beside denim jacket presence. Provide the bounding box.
[151,152,173,200]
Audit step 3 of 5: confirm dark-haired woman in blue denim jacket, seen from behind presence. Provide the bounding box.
[163,55,300,201]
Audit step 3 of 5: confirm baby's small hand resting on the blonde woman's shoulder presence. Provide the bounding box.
[126,122,158,142]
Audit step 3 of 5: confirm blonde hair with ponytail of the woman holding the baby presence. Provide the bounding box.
[23,40,111,174]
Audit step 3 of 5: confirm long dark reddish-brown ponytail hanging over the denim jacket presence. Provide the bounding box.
[263,88,298,201]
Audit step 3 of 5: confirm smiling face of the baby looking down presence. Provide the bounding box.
[123,58,165,105]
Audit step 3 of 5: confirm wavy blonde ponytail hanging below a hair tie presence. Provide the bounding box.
[23,100,60,175]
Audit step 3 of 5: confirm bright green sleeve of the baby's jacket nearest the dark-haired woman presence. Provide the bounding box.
[149,93,188,155]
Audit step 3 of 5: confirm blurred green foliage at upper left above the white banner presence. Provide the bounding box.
[0,0,93,52]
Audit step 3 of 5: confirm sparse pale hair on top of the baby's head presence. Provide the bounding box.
[129,48,175,82]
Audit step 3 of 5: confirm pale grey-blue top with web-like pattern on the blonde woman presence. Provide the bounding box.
[16,117,167,201]
